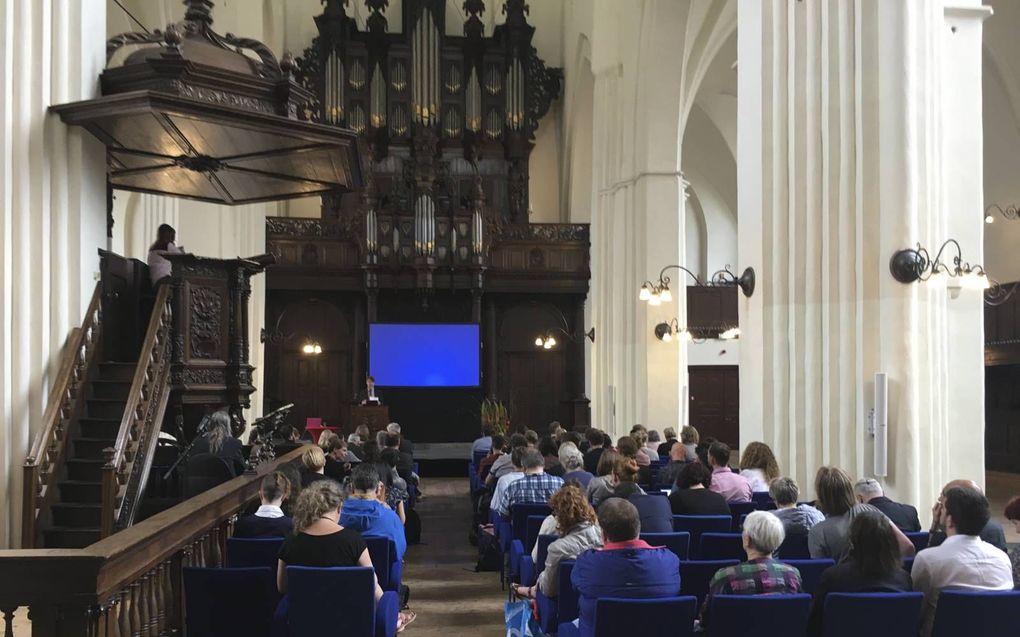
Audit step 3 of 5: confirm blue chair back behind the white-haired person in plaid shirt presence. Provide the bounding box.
[709,594,811,637]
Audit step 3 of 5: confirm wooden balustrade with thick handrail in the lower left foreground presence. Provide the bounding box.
[0,448,303,637]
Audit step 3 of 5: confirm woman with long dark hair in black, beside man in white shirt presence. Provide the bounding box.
[807,509,911,635]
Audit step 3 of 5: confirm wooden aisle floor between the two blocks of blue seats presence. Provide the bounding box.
[402,478,506,637]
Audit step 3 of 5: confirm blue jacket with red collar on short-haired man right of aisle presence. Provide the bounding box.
[570,540,680,637]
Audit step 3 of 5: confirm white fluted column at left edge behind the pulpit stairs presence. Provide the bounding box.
[0,0,106,546]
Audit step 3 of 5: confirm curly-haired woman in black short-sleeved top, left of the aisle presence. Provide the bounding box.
[276,481,415,630]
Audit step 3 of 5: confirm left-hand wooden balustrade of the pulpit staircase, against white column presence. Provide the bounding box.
[21,283,103,548]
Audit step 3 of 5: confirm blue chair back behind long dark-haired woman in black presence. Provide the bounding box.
[822,593,924,637]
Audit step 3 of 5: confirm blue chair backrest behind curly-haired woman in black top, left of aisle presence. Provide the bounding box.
[285,567,375,637]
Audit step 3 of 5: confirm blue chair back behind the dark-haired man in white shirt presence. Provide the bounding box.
[931,590,1020,637]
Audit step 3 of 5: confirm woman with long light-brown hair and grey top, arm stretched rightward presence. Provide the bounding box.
[808,467,914,563]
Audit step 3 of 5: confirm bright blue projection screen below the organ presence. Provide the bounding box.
[368,323,480,387]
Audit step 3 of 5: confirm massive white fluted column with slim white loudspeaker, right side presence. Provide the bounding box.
[738,0,983,512]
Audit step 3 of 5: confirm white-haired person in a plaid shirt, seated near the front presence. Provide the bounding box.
[701,511,801,627]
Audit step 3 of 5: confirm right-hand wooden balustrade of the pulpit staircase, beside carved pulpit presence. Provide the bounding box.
[100,285,172,537]
